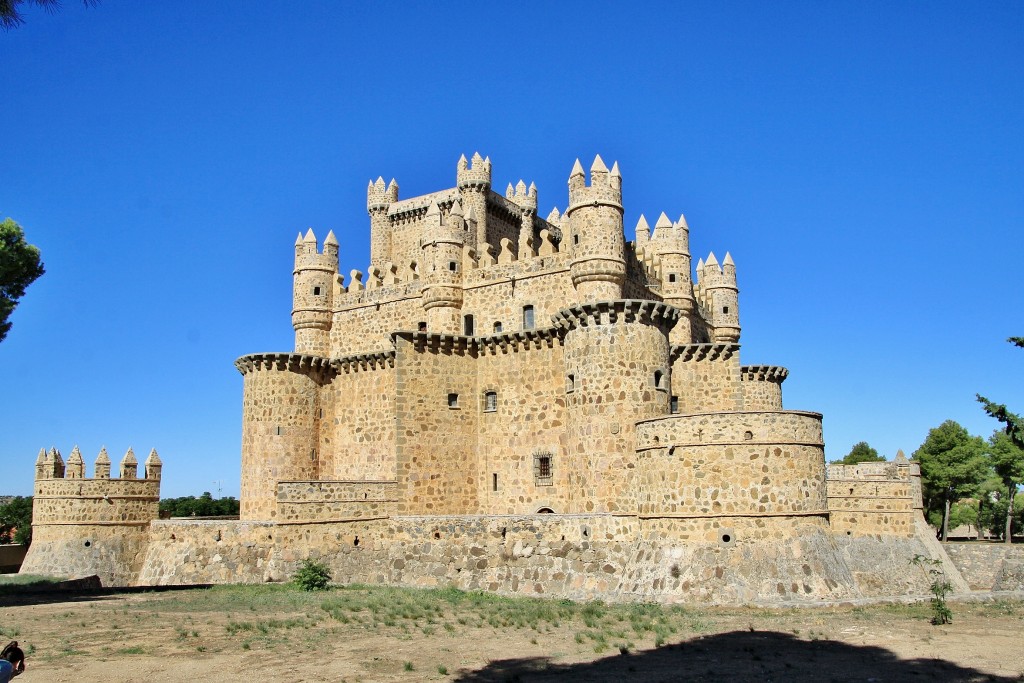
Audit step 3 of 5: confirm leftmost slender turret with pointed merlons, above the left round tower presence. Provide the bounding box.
[292,228,338,357]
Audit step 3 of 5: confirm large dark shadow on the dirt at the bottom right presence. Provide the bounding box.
[455,631,1024,683]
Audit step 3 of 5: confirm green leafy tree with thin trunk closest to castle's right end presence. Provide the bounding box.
[913,420,988,541]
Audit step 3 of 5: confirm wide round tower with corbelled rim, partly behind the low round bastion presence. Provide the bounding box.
[555,300,679,513]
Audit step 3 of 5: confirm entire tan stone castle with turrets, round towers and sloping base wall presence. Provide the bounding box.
[23,155,966,602]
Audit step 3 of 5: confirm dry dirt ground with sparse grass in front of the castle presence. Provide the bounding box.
[0,587,1024,683]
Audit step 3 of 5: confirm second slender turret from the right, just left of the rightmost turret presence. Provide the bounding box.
[649,213,696,344]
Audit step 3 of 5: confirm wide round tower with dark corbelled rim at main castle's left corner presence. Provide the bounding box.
[234,353,330,520]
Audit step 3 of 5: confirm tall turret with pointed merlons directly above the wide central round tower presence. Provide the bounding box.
[565,156,626,301]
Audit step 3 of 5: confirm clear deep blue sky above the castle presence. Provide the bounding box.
[0,0,1024,496]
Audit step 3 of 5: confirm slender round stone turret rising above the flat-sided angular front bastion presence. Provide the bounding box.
[420,200,466,335]
